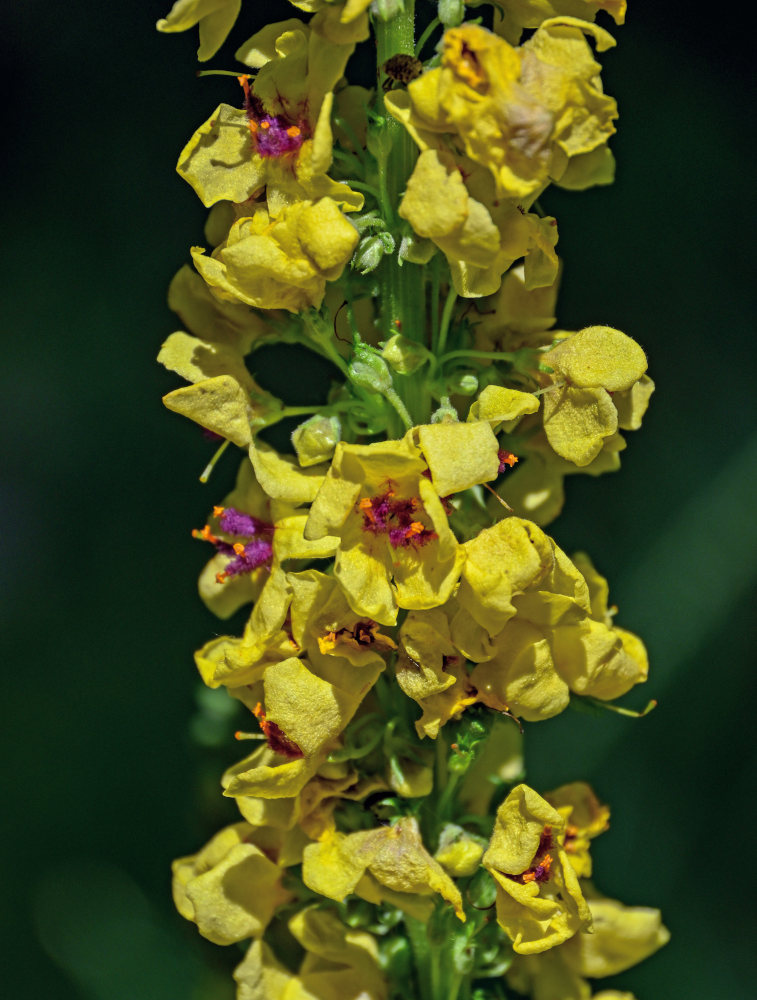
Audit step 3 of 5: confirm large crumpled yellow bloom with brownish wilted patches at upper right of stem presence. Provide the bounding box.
[386,17,617,202]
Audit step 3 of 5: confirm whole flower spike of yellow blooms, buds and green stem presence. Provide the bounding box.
[158,0,667,1000]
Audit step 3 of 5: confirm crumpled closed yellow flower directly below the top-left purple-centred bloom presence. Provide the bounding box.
[192,198,359,312]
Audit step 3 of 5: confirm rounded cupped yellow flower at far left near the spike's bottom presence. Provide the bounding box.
[173,823,291,944]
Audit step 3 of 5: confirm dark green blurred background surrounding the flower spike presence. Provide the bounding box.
[0,0,757,1000]
